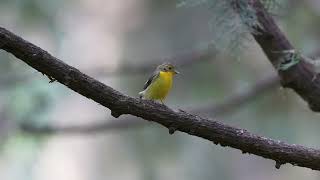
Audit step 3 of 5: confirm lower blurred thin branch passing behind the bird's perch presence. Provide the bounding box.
[20,75,279,135]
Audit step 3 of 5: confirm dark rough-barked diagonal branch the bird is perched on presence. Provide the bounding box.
[0,28,320,170]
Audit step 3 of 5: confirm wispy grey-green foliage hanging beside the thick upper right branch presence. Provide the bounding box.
[177,0,279,55]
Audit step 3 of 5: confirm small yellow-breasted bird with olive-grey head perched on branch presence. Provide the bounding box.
[139,63,179,104]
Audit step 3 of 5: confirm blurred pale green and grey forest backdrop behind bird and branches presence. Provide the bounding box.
[0,0,320,180]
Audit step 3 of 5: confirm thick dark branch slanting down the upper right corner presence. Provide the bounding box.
[245,0,320,112]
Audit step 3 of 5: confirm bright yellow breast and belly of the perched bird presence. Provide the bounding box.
[146,71,173,100]
